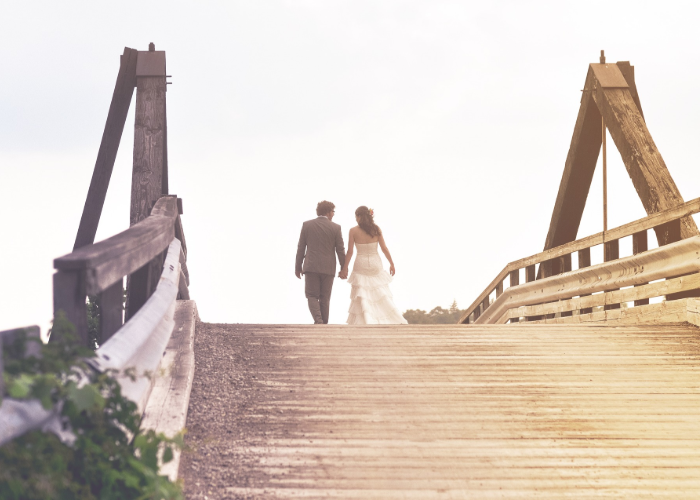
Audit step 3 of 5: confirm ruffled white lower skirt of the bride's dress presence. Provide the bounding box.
[348,269,408,325]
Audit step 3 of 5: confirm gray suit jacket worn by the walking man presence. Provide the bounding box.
[295,216,345,276]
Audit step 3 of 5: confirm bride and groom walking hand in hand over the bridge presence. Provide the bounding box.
[295,201,407,325]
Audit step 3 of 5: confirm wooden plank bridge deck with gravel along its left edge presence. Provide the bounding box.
[180,324,700,499]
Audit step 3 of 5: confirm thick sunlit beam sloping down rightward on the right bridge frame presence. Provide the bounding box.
[591,73,700,238]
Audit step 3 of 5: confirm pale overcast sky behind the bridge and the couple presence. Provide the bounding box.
[0,0,700,330]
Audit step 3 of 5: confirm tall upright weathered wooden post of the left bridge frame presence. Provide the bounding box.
[126,44,167,319]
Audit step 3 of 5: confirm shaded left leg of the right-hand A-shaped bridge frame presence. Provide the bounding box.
[544,72,602,250]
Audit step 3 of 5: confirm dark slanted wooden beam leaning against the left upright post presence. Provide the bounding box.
[73,47,138,250]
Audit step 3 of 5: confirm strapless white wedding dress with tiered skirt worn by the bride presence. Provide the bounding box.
[348,241,408,325]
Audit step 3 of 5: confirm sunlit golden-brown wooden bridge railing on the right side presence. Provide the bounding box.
[459,198,700,324]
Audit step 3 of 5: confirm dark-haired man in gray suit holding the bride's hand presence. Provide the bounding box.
[294,201,345,325]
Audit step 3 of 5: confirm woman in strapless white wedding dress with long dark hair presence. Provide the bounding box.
[339,206,408,325]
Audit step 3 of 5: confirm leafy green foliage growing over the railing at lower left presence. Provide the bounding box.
[0,316,183,500]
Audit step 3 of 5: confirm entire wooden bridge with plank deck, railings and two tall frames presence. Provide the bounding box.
[0,47,700,499]
